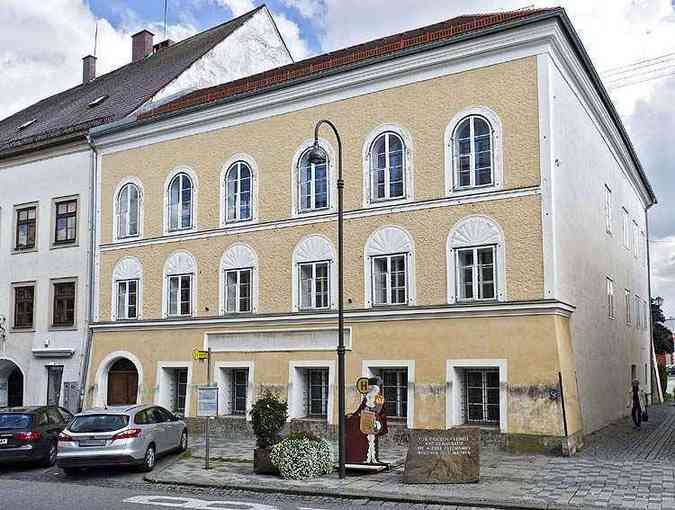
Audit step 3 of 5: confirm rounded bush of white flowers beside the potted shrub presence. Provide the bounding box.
[271,434,333,480]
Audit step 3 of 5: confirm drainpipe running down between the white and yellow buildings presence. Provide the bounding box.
[78,135,98,410]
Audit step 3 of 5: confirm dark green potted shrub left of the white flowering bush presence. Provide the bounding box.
[251,390,288,474]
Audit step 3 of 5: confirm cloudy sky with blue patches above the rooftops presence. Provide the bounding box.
[0,0,675,315]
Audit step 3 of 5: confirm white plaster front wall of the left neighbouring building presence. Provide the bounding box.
[0,145,91,405]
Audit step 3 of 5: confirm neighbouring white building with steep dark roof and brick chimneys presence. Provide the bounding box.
[0,7,292,409]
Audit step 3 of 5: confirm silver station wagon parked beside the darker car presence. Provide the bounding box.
[56,405,188,475]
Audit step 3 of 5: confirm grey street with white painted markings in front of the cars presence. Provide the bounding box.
[0,457,496,510]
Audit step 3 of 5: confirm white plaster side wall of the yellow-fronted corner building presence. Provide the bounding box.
[538,55,652,433]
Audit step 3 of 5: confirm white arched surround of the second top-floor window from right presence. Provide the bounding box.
[362,124,415,208]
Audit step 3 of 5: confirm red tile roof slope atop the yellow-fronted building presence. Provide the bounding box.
[139,8,561,119]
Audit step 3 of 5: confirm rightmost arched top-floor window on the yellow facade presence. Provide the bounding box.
[452,115,495,189]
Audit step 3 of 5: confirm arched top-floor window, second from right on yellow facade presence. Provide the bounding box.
[370,132,406,201]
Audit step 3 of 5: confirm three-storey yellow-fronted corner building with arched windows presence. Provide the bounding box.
[85,10,654,451]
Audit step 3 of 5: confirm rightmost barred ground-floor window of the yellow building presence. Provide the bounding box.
[464,368,499,424]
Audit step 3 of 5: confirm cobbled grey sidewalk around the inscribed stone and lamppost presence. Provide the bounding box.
[146,404,675,510]
